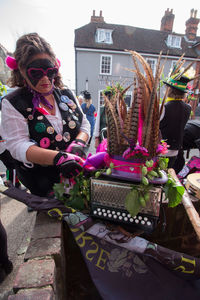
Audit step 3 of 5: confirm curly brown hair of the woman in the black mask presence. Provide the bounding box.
[8,33,63,88]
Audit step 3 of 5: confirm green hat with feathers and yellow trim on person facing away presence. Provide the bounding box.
[163,55,196,93]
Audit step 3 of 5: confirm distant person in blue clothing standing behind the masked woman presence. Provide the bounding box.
[81,91,96,145]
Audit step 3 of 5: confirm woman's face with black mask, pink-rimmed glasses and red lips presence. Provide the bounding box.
[21,54,58,93]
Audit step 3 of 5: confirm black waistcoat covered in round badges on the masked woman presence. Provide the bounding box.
[6,88,83,169]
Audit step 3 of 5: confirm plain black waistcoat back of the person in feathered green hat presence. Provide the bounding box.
[160,100,191,150]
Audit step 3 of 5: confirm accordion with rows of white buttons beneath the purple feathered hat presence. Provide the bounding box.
[90,178,162,232]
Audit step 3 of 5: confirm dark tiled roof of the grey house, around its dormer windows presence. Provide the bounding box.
[74,22,200,58]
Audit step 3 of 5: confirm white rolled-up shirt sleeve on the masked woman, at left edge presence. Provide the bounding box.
[1,99,35,163]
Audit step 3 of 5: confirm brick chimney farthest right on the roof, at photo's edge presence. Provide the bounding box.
[185,8,200,41]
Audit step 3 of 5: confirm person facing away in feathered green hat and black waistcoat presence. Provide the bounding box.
[160,59,192,171]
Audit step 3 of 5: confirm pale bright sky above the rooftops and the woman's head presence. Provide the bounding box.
[0,0,200,89]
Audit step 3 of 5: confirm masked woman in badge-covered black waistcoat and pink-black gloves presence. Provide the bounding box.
[2,33,90,196]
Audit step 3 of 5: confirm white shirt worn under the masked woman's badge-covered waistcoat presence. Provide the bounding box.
[1,94,90,163]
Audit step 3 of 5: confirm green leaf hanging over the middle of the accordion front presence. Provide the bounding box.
[125,189,141,217]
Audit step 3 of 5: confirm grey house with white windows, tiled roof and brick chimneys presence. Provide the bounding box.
[74,9,200,108]
